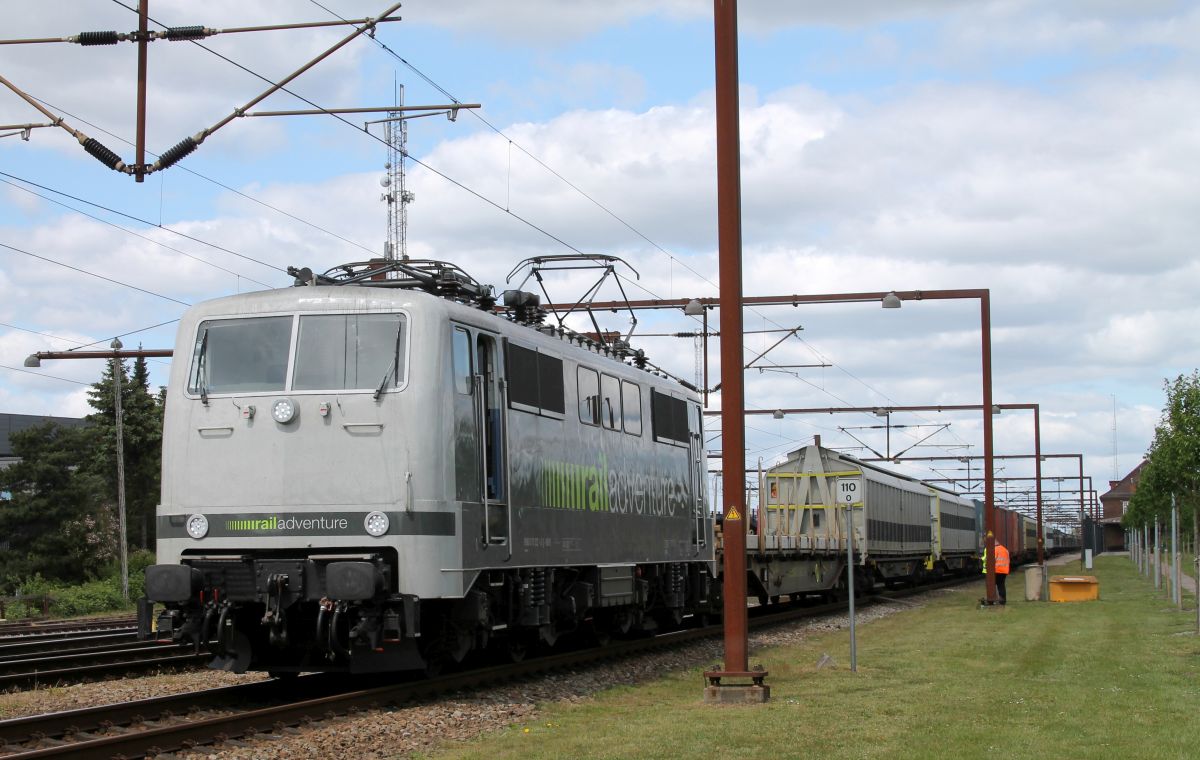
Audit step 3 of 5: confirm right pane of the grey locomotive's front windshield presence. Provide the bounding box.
[292,313,404,390]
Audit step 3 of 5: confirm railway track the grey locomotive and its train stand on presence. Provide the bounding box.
[0,578,977,760]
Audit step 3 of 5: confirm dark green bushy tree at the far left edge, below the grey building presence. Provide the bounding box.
[0,423,116,592]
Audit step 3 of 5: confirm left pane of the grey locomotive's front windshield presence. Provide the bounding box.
[187,317,292,395]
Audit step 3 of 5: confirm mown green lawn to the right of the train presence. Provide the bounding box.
[431,556,1200,760]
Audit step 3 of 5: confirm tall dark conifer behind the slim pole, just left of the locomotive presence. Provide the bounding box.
[88,357,166,549]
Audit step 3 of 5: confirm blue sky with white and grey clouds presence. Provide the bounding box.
[0,0,1200,521]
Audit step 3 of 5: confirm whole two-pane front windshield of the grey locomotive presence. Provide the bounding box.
[187,313,406,397]
